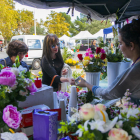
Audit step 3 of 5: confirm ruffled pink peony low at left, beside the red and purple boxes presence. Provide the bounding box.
[3,105,22,129]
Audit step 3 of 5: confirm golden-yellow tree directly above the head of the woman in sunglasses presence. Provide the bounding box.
[44,11,70,37]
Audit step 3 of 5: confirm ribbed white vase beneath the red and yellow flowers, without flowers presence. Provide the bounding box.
[86,72,101,86]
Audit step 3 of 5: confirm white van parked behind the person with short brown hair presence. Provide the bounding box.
[11,35,45,70]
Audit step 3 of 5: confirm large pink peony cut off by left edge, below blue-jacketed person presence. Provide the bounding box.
[0,68,16,87]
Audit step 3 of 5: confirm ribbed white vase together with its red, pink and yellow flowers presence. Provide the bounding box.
[78,47,106,86]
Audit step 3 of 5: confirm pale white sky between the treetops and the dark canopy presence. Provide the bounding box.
[15,2,80,22]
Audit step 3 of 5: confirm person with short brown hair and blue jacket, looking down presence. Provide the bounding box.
[0,40,29,71]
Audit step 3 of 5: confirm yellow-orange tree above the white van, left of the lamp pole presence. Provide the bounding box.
[15,10,34,35]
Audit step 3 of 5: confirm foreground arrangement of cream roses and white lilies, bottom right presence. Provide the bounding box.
[58,90,140,140]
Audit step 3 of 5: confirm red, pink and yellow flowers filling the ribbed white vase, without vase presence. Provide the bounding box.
[77,47,106,72]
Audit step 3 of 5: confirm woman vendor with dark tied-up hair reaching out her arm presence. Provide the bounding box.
[77,19,140,104]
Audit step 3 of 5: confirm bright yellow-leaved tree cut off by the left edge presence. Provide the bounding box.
[0,0,18,40]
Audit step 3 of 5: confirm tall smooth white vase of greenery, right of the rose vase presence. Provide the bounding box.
[107,62,121,86]
